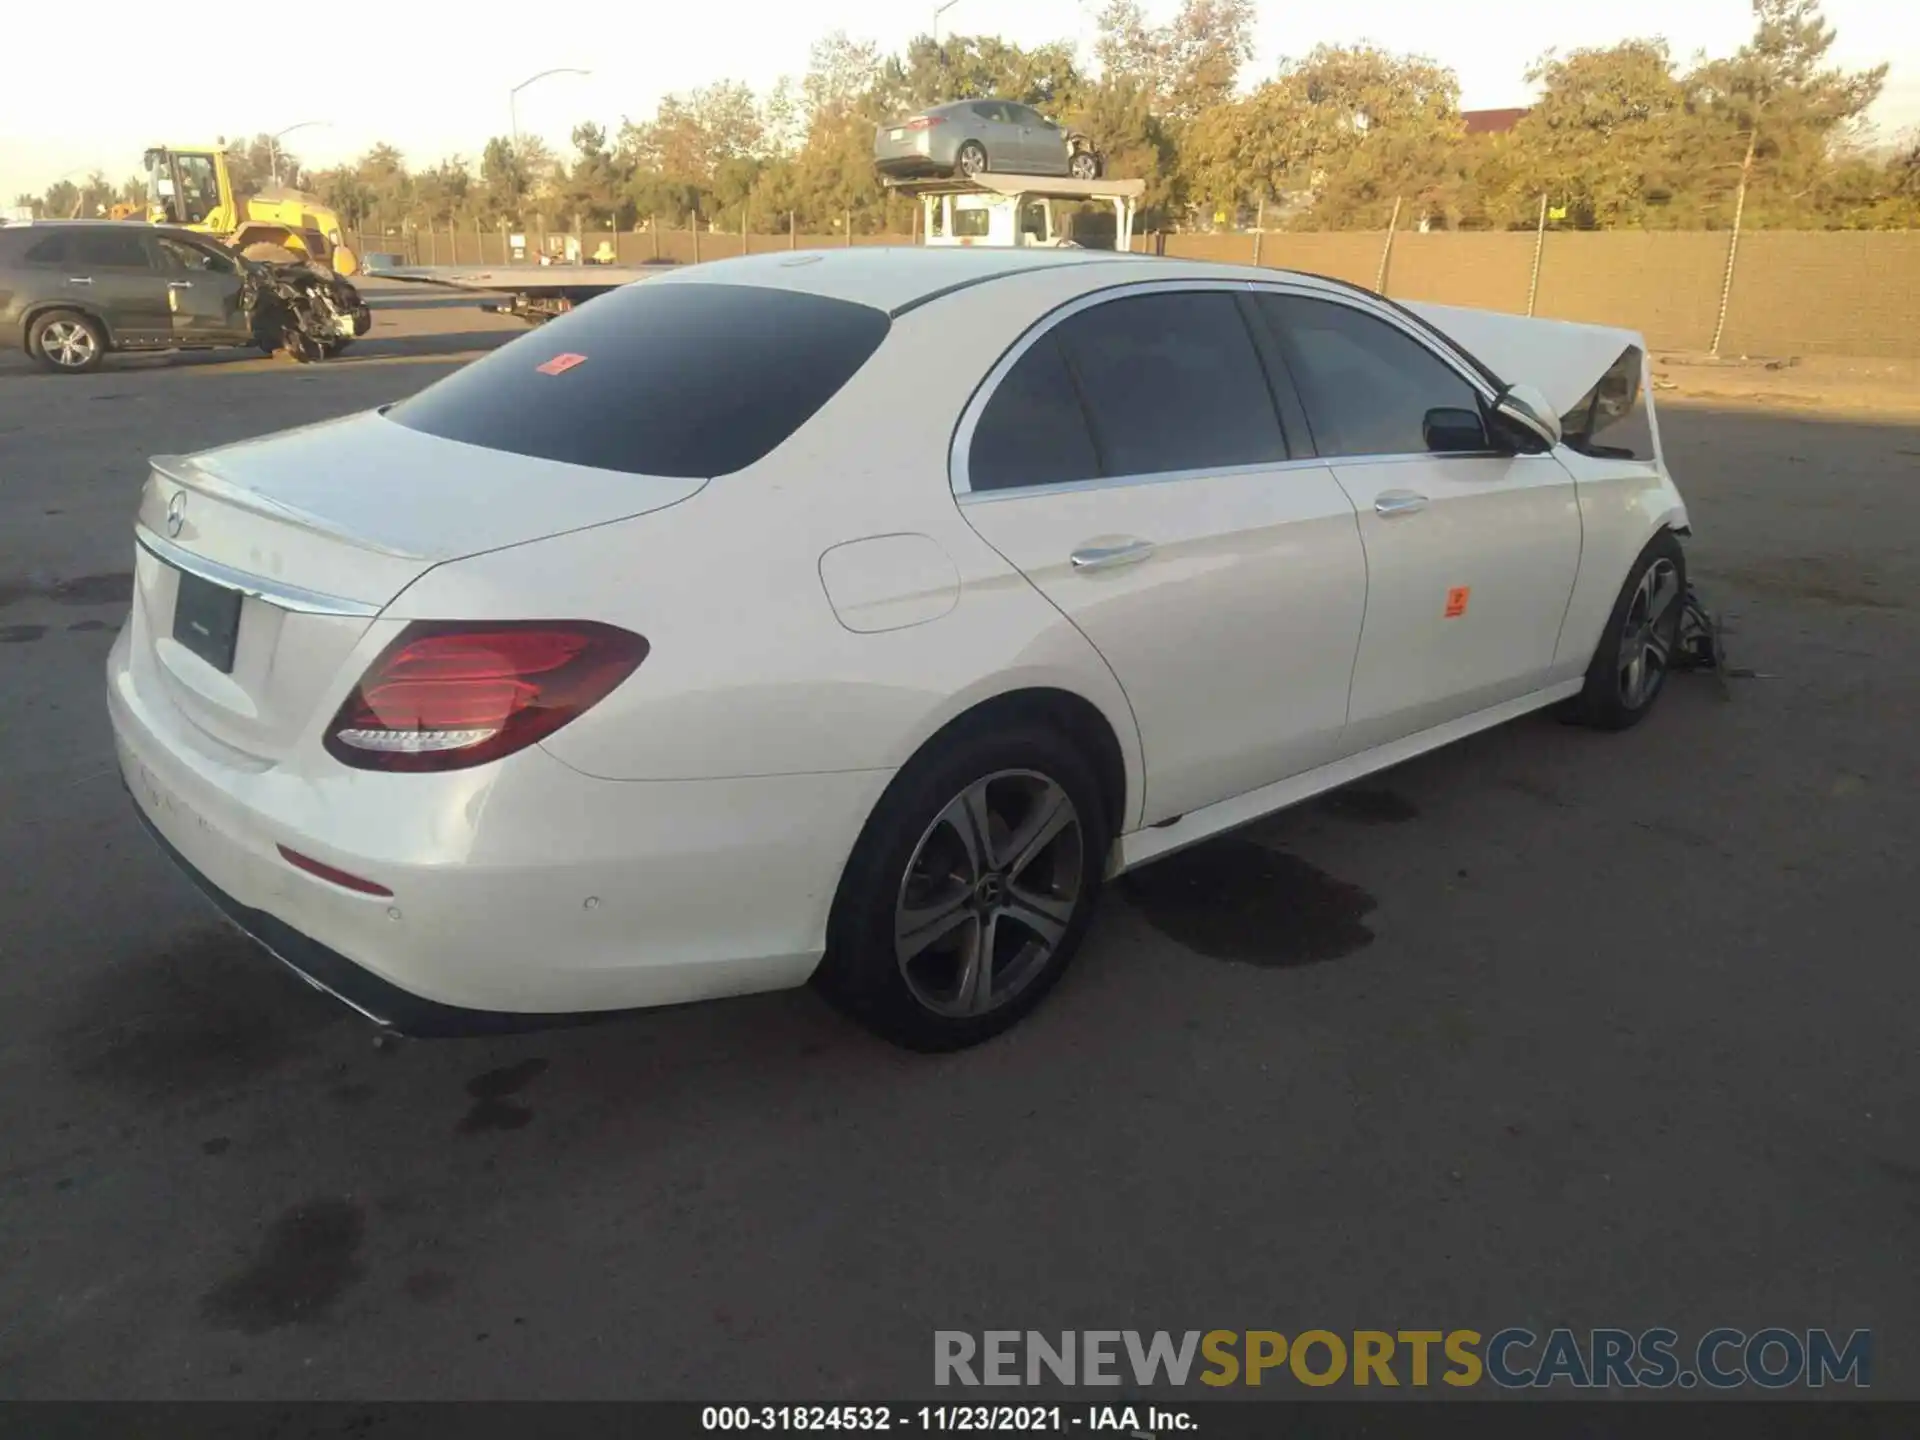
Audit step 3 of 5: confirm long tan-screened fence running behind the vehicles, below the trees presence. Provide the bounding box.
[351,217,1920,357]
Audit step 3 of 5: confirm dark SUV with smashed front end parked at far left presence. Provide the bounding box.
[0,221,353,374]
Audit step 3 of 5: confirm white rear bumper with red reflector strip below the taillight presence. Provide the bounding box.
[108,626,889,1035]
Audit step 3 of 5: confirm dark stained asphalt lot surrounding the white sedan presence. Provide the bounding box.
[0,282,1920,1400]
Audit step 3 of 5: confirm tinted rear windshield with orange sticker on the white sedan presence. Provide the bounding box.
[386,280,889,478]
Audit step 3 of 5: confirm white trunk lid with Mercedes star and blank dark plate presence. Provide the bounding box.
[134,411,707,762]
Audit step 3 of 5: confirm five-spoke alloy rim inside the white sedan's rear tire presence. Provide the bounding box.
[893,770,1085,1016]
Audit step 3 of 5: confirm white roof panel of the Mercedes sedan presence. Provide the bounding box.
[645,246,1397,324]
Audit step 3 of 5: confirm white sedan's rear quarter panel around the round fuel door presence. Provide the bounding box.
[386,267,1140,824]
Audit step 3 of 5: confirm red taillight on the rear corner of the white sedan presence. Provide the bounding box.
[326,620,647,770]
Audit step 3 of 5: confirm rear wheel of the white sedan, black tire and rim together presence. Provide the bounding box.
[814,726,1110,1052]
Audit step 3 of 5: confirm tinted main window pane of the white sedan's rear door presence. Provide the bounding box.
[1056,290,1286,476]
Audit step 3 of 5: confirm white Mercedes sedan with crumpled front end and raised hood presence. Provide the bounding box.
[108,248,1688,1050]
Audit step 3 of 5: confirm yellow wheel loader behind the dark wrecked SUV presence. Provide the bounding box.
[146,146,359,275]
